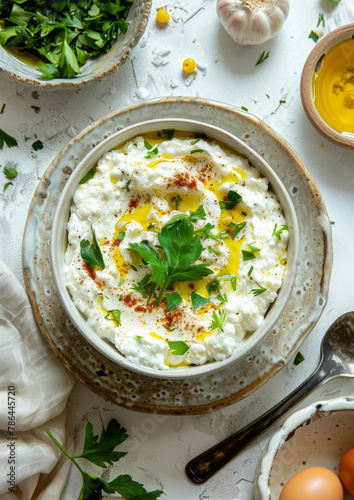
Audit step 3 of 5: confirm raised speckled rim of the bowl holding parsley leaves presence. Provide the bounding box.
[0,0,152,91]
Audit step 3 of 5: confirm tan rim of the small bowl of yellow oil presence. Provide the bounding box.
[300,23,354,149]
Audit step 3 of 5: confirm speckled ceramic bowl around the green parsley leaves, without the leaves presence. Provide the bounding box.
[0,0,151,90]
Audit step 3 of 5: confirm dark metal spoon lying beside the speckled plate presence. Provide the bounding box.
[186,312,354,483]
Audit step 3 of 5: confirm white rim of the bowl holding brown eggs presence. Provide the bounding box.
[254,396,354,500]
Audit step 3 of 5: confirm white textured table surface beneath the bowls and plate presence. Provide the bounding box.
[0,0,354,500]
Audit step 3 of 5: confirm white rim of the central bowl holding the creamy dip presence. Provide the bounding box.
[51,118,299,379]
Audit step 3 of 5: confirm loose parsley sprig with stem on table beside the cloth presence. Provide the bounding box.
[47,419,163,500]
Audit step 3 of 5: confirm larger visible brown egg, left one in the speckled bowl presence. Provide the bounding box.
[279,467,344,500]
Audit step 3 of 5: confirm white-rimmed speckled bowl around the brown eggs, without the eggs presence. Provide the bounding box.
[254,397,354,500]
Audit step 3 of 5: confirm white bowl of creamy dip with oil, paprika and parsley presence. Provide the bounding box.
[51,119,299,378]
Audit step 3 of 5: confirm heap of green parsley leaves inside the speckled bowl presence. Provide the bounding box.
[0,0,133,78]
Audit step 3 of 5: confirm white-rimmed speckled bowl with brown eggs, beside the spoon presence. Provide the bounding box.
[254,397,354,500]
